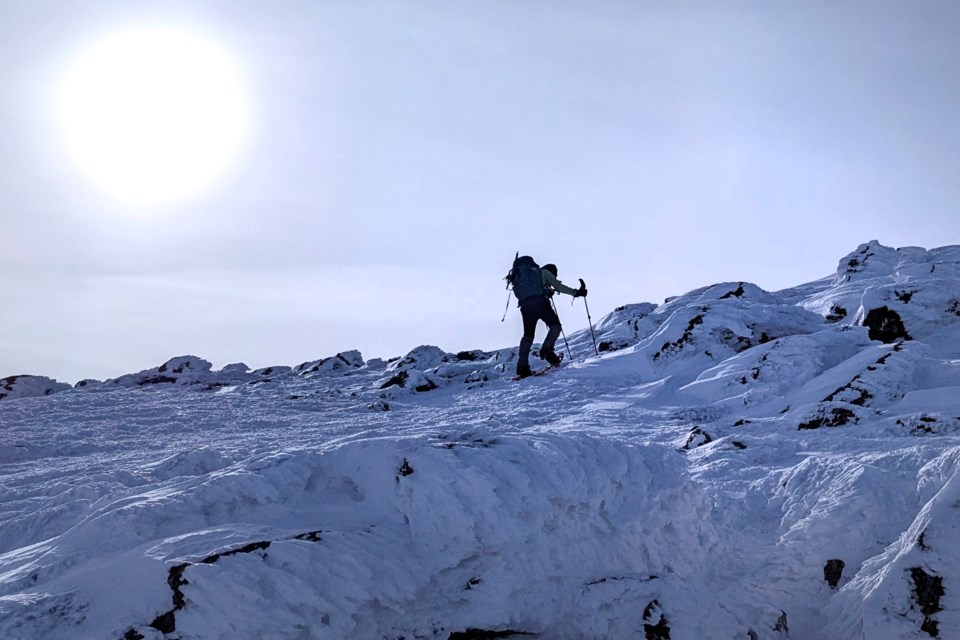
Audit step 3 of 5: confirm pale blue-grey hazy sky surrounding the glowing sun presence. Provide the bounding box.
[0,0,960,383]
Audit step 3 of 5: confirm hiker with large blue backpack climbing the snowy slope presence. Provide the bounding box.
[507,256,587,378]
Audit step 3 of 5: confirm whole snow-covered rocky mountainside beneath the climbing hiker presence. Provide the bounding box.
[0,242,960,640]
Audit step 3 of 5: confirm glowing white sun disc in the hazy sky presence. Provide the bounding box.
[60,29,246,205]
